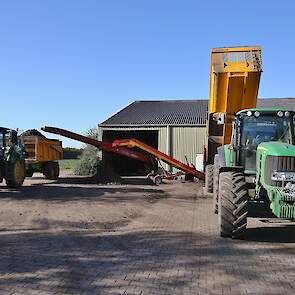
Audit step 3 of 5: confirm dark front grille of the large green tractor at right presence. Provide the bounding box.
[264,156,295,186]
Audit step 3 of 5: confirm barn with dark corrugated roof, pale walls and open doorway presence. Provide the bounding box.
[98,98,295,175]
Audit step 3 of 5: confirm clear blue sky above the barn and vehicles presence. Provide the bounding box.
[0,0,295,146]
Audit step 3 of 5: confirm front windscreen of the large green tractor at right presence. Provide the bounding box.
[241,115,292,170]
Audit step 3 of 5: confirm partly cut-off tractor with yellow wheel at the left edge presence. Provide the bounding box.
[0,127,26,188]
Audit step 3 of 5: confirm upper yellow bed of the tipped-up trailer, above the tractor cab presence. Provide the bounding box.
[208,47,262,113]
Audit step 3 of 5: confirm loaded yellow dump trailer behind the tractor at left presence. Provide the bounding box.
[23,132,62,179]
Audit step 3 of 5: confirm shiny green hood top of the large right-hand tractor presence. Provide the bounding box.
[257,141,295,157]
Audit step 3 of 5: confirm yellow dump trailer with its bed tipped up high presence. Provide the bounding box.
[204,46,262,193]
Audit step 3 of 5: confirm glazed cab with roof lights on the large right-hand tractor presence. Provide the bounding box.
[232,109,295,174]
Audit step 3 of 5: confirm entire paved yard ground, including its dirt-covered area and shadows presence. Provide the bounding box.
[0,175,295,295]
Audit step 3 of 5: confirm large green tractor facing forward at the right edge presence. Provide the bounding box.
[213,108,295,238]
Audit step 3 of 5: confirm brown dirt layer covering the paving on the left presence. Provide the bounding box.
[0,172,167,235]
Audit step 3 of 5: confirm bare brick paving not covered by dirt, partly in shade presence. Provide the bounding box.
[0,177,295,295]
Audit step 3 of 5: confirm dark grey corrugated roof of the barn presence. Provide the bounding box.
[100,98,295,127]
